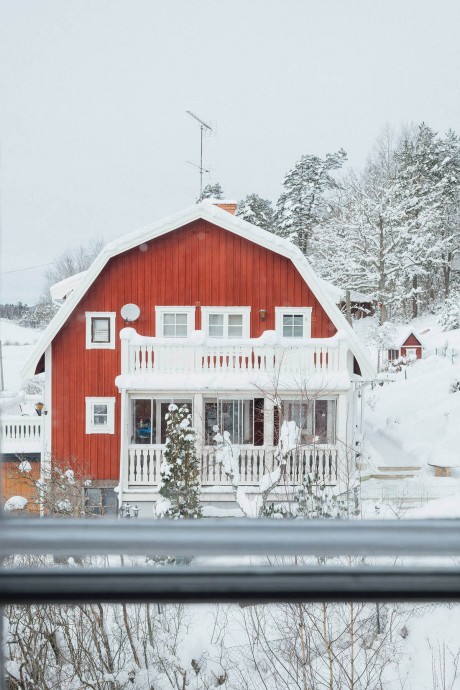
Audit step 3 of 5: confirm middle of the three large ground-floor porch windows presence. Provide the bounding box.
[204,398,264,446]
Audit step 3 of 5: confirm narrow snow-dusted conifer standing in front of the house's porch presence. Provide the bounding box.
[160,404,202,519]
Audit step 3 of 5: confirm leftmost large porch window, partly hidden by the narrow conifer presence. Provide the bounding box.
[131,398,192,445]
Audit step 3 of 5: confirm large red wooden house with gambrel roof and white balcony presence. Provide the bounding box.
[23,202,374,514]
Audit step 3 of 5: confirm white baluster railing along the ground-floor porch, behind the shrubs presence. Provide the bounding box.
[124,444,338,490]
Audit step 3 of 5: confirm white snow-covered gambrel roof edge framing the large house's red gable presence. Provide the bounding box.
[21,201,375,379]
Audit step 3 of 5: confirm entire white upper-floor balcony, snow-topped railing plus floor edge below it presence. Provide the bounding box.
[116,328,350,390]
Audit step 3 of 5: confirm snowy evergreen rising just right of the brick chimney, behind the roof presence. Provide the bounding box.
[275,149,347,255]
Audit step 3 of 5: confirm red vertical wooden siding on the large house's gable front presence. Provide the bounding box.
[52,220,336,480]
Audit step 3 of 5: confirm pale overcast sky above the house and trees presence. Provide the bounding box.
[0,0,460,303]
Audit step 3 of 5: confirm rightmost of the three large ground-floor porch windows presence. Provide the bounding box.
[275,399,337,445]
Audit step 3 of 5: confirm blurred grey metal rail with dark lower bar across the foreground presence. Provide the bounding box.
[0,518,460,604]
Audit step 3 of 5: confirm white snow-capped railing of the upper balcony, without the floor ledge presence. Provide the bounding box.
[121,328,347,376]
